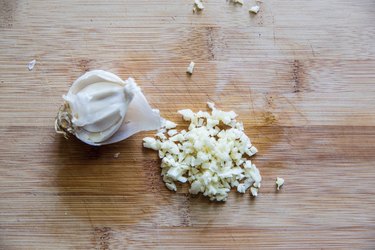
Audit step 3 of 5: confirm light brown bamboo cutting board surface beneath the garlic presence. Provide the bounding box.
[0,0,375,249]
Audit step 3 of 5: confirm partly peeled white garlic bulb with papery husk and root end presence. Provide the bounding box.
[55,70,162,146]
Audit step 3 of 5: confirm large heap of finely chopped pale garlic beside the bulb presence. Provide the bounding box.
[143,103,262,201]
